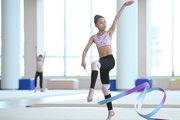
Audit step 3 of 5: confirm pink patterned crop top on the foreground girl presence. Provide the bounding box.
[94,31,112,48]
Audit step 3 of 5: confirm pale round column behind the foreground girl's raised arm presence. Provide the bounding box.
[116,0,137,90]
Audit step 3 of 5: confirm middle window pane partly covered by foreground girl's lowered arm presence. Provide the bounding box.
[66,0,91,76]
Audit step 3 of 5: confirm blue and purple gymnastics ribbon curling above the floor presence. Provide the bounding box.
[98,82,167,120]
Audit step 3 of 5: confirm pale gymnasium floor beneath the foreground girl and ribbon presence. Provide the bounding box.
[0,90,180,120]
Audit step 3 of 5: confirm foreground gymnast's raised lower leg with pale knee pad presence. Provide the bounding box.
[87,61,101,102]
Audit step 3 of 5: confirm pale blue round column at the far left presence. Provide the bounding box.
[1,0,21,90]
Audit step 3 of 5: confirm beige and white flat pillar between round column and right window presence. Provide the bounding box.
[138,0,151,78]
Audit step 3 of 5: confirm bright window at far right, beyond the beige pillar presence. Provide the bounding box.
[151,0,180,76]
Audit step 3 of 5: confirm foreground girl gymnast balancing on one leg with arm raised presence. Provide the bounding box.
[81,0,134,120]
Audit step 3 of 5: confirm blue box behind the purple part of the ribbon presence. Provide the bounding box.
[135,78,152,91]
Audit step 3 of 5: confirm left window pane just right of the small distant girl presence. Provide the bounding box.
[44,0,64,76]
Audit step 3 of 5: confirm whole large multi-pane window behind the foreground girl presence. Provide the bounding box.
[44,0,116,76]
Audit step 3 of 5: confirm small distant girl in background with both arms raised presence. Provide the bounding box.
[34,46,46,92]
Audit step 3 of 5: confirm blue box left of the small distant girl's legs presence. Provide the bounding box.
[19,78,34,90]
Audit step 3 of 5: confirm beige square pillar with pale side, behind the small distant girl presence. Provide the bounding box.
[24,0,44,78]
